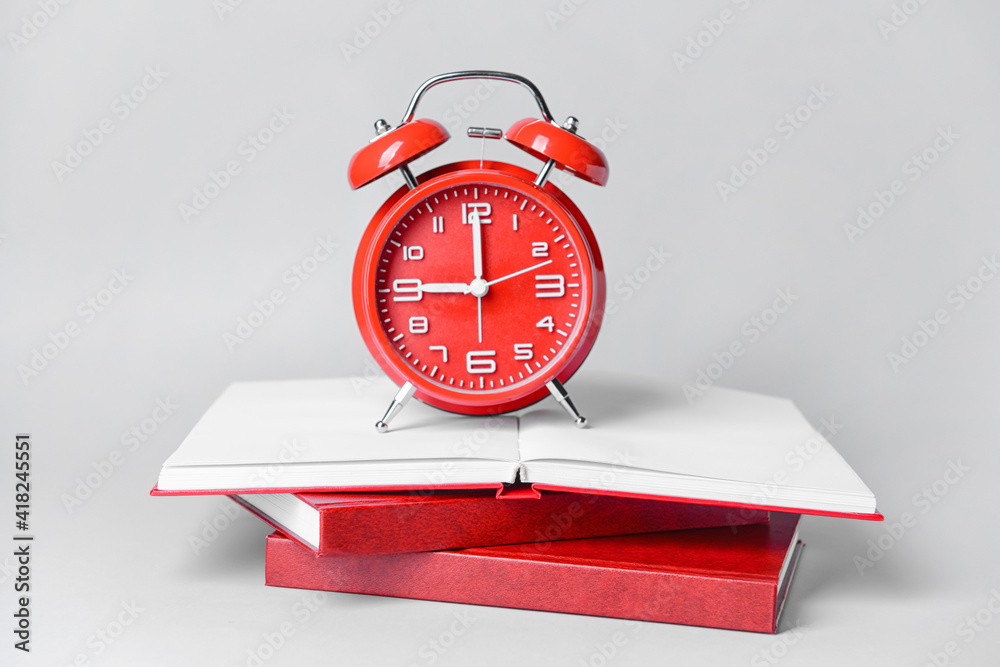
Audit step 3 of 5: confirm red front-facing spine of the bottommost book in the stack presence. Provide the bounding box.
[266,533,777,632]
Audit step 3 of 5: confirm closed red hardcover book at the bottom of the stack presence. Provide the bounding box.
[266,514,801,632]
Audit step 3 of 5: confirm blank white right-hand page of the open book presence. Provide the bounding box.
[519,373,873,498]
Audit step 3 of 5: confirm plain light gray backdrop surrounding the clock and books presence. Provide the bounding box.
[0,0,1000,666]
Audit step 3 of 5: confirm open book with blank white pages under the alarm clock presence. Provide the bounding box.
[154,373,881,519]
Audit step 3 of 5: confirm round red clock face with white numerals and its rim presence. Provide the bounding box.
[356,164,603,409]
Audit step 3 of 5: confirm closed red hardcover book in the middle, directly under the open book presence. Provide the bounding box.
[232,488,768,555]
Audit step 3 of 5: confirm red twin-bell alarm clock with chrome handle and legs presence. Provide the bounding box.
[348,71,608,432]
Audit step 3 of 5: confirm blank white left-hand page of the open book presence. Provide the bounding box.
[164,378,517,468]
